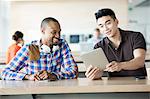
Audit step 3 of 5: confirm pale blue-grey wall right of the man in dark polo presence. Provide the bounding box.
[128,6,150,48]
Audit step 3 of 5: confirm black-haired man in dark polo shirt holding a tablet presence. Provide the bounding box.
[85,8,147,79]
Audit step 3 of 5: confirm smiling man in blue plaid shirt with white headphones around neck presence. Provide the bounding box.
[1,17,78,81]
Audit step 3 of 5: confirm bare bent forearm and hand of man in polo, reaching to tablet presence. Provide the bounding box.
[105,49,146,72]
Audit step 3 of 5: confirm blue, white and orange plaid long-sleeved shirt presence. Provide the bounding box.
[1,39,78,80]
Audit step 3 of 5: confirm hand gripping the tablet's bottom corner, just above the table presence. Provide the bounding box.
[85,65,103,80]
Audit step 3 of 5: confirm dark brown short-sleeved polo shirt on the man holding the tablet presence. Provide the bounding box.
[94,29,147,77]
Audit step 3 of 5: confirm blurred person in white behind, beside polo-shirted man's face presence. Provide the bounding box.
[87,28,103,46]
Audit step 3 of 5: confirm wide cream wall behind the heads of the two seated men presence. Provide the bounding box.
[10,0,128,41]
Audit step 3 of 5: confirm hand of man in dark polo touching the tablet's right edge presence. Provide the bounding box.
[105,61,122,72]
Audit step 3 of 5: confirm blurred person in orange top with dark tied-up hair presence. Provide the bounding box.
[6,31,24,64]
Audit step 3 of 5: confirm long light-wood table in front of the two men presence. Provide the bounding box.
[0,77,150,99]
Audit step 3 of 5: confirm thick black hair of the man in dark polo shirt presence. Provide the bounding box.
[95,8,116,20]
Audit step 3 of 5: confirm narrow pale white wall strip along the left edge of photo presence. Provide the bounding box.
[0,0,10,62]
